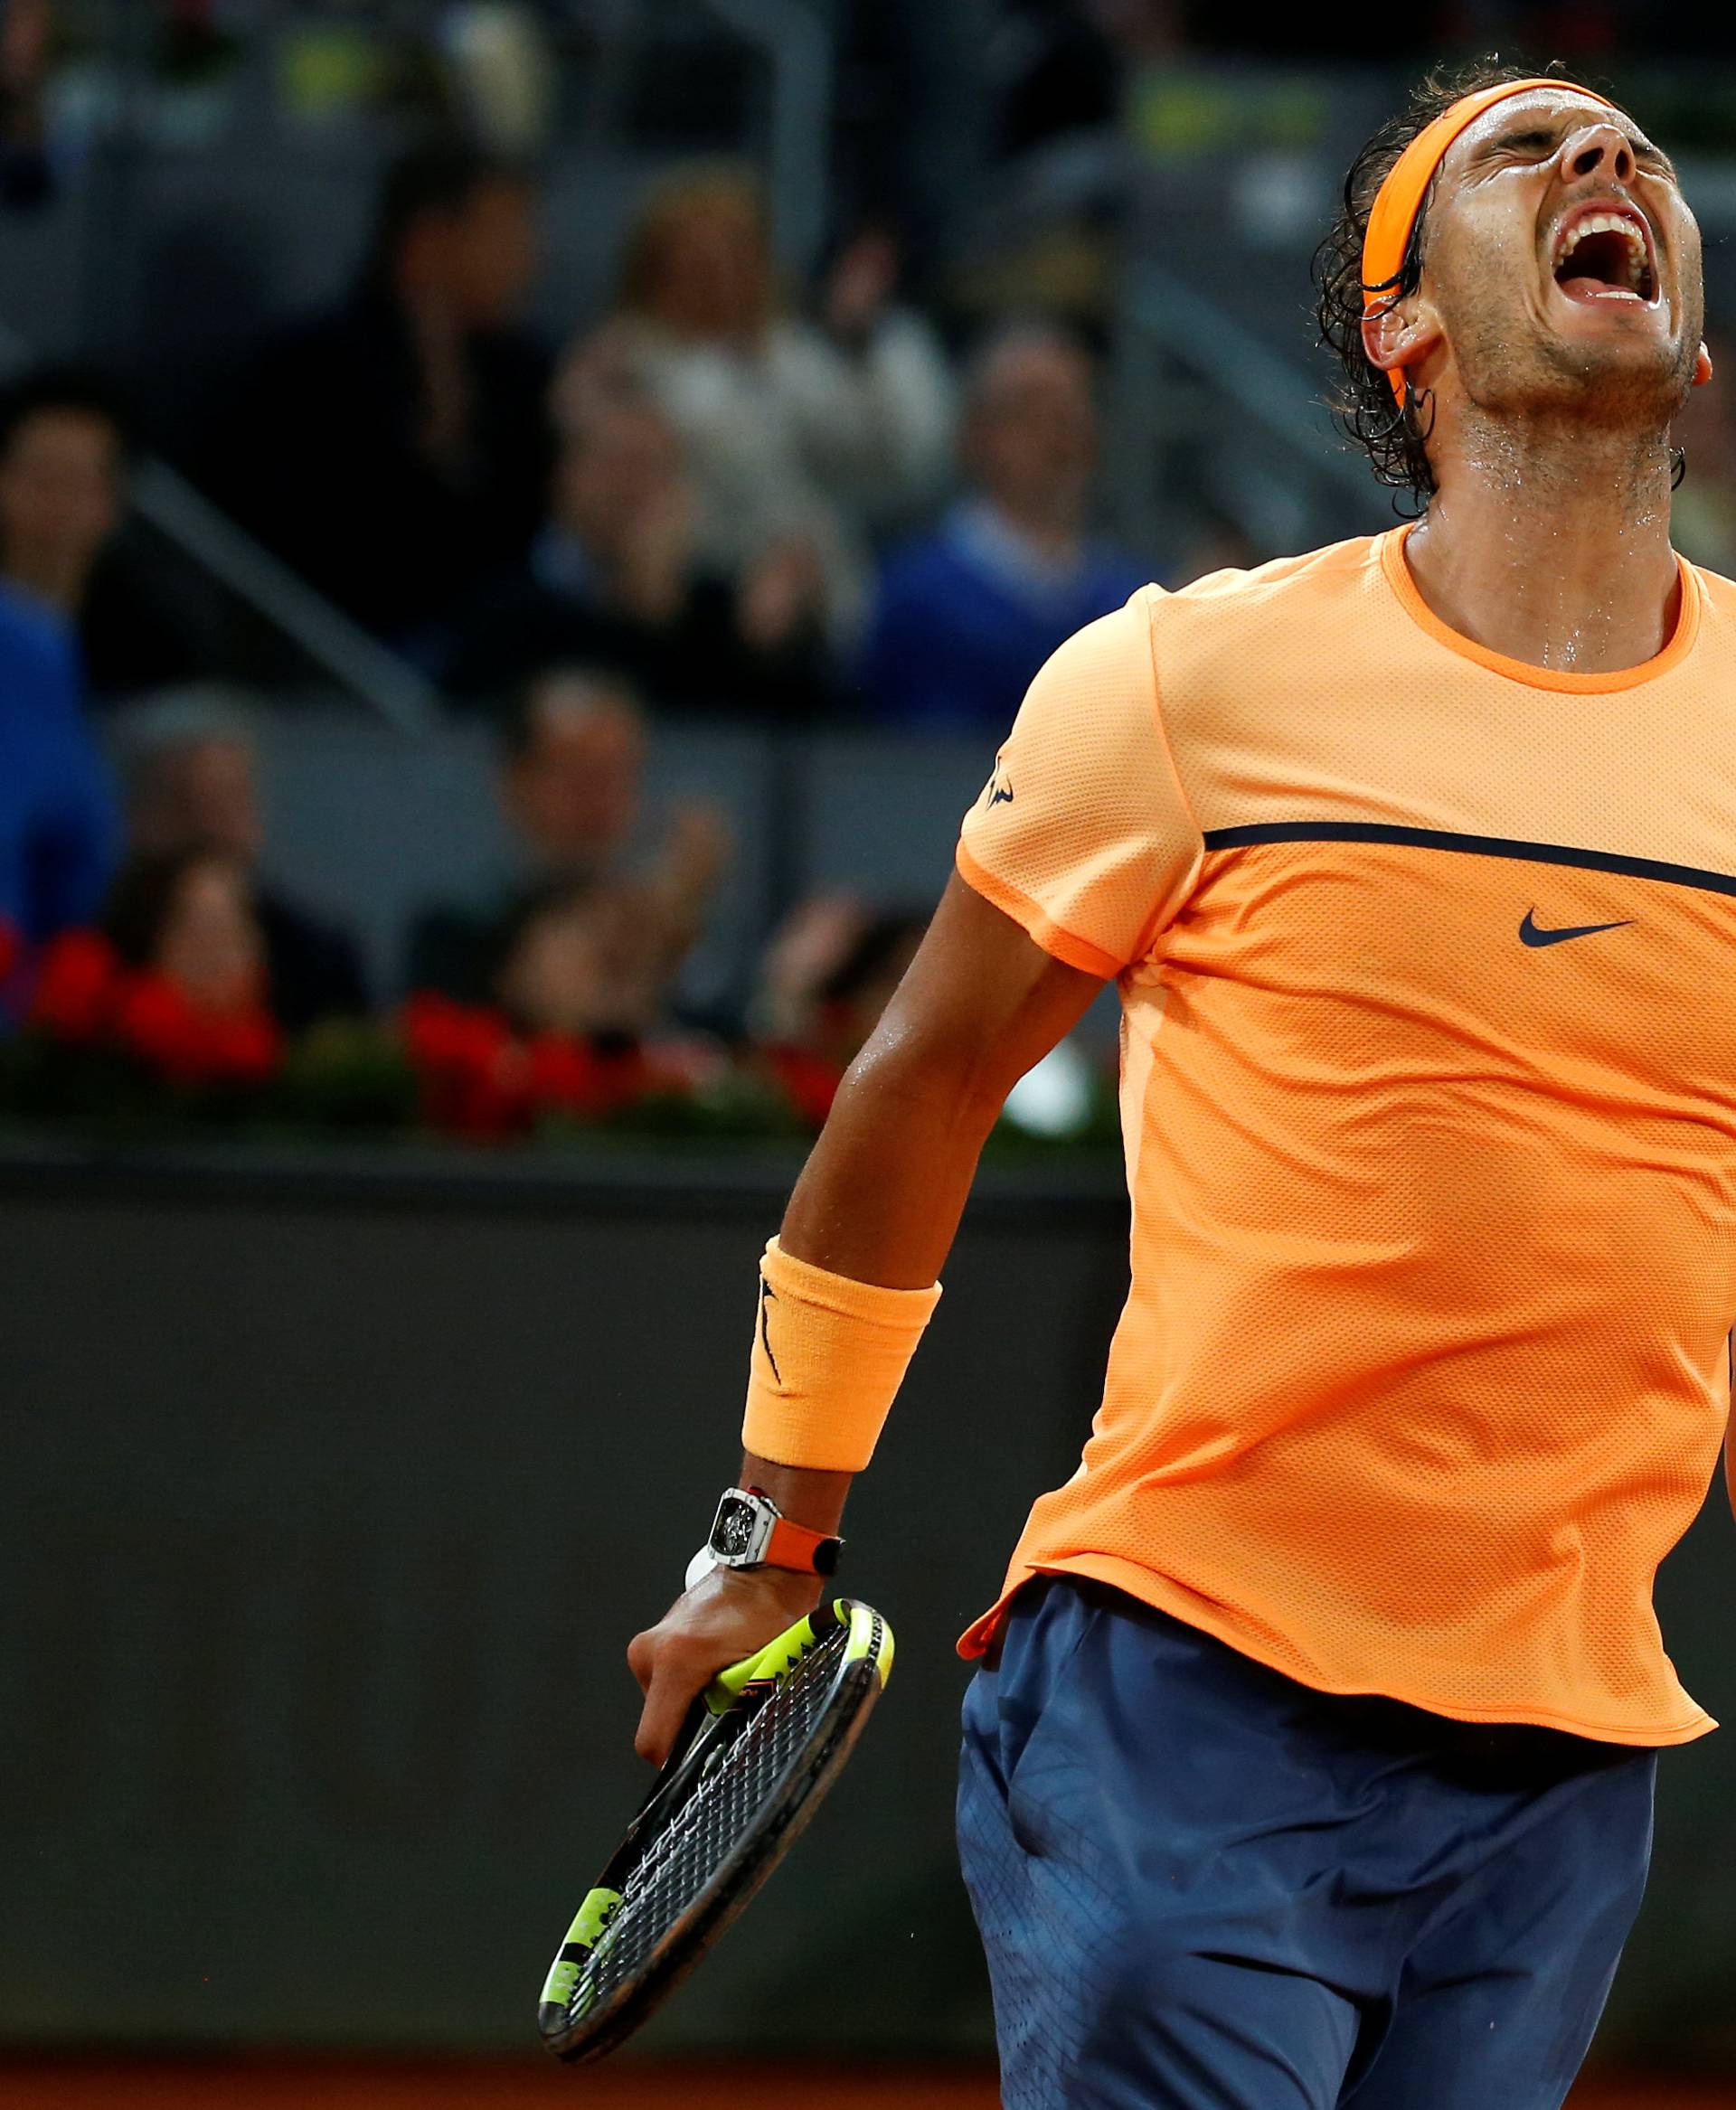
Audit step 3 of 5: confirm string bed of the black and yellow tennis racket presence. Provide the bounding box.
[568,1635,844,2020]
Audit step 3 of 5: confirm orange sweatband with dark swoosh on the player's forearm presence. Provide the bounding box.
[742,1239,940,1473]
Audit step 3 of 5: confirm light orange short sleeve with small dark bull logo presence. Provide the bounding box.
[958,589,1204,977]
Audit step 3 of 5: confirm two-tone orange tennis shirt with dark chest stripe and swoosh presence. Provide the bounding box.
[958,532,1736,1745]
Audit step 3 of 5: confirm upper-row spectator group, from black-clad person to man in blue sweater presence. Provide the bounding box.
[173,141,1143,726]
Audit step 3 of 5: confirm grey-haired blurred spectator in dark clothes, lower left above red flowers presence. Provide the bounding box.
[122,686,367,1034]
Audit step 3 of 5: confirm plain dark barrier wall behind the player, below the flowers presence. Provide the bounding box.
[0,1158,1736,2072]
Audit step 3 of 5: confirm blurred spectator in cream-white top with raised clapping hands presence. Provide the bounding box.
[590,166,951,626]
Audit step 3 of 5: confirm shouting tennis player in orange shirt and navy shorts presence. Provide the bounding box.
[631,71,1736,2110]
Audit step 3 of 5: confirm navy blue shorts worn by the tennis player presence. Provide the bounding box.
[958,1578,1656,2110]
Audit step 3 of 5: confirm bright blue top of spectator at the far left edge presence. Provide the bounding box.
[0,582,120,943]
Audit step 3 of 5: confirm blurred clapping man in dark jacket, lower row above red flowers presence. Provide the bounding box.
[410,669,728,1003]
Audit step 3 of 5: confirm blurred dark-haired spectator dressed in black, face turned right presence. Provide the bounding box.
[204,141,551,648]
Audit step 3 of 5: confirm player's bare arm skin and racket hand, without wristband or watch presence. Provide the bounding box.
[628,878,1103,1762]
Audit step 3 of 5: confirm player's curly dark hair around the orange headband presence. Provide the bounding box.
[1314,59,1565,513]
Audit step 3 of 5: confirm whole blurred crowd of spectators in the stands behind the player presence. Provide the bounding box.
[0,0,1736,1118]
